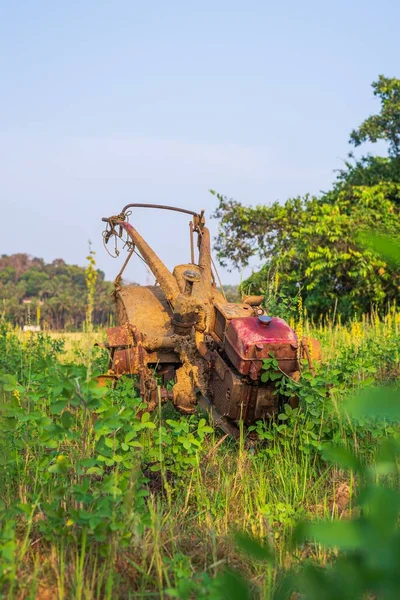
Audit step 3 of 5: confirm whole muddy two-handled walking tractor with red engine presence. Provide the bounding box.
[103,204,319,433]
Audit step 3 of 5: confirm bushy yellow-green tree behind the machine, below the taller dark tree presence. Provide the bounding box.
[215,183,400,318]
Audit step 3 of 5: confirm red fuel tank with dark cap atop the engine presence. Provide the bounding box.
[224,315,299,380]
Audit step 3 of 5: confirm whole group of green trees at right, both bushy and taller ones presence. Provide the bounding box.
[212,75,400,318]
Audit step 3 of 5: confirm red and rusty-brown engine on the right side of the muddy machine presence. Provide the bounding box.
[210,305,300,423]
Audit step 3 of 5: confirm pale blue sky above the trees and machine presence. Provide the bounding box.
[0,0,400,283]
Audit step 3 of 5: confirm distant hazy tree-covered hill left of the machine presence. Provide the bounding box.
[0,254,114,330]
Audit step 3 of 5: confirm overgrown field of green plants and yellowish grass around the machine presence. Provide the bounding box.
[0,311,400,600]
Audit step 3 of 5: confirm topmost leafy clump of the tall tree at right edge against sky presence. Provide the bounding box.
[350,75,400,158]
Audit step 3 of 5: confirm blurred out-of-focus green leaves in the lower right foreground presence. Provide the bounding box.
[216,389,400,600]
